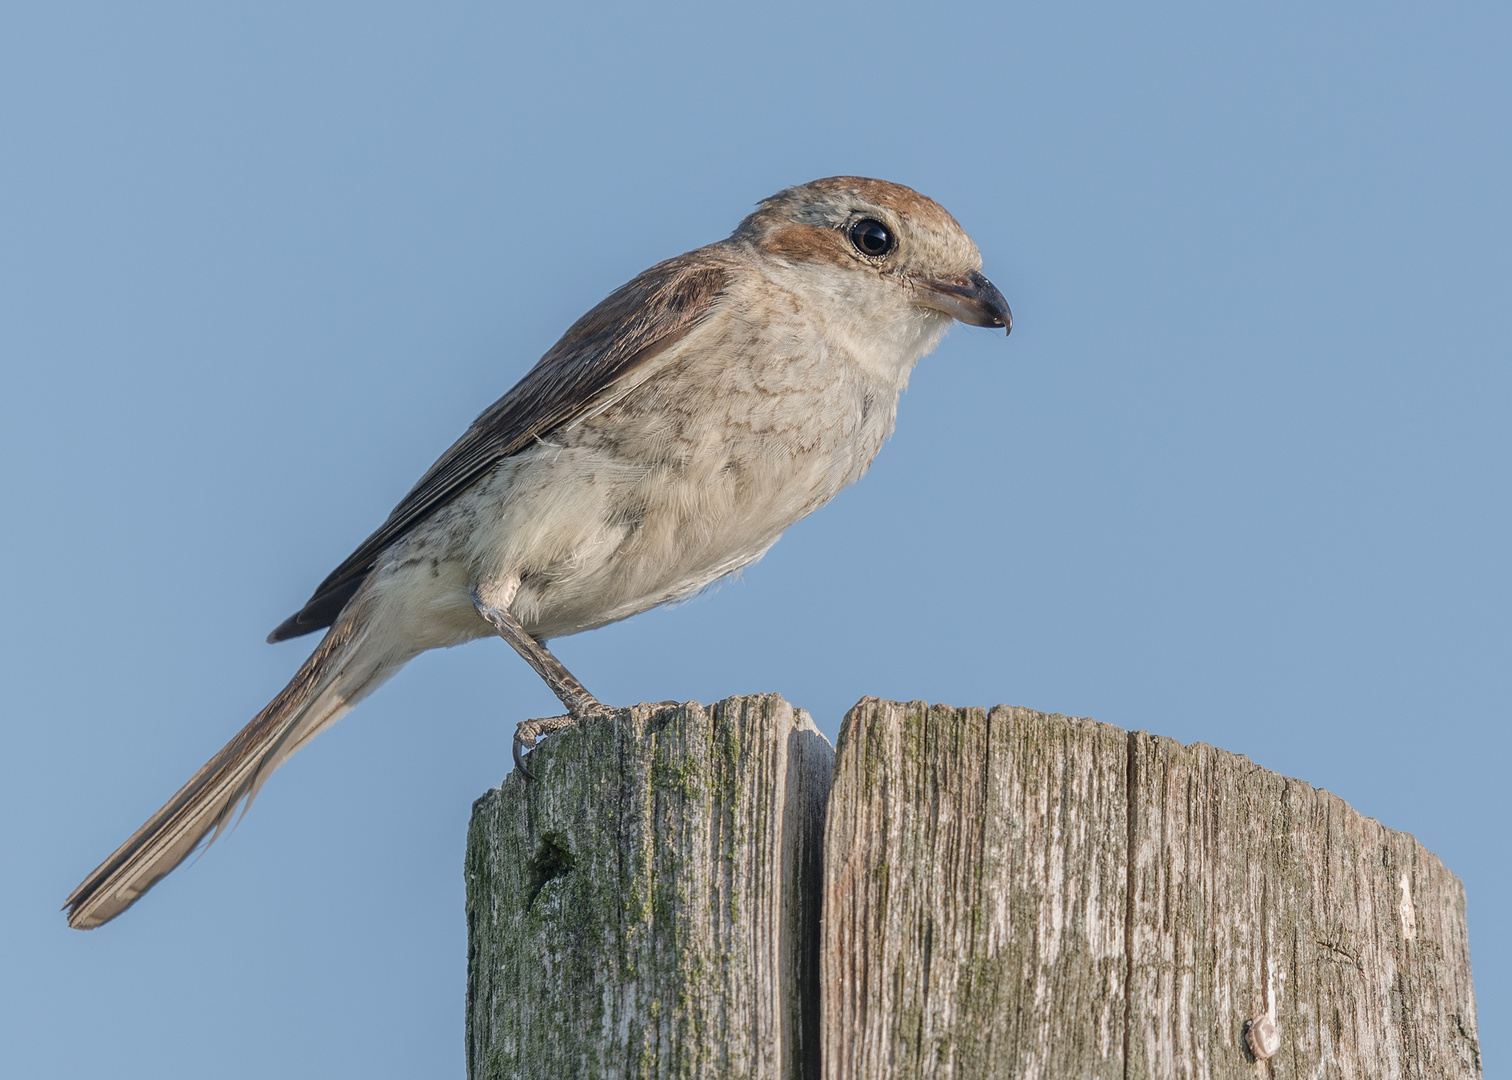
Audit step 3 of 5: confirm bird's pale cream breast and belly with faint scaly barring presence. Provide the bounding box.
[453,275,922,638]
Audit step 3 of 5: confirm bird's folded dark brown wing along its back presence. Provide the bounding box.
[268,248,730,641]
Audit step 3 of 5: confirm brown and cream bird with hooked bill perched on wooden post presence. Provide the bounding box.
[64,177,1013,929]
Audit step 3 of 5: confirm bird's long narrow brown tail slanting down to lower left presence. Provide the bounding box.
[64,595,410,930]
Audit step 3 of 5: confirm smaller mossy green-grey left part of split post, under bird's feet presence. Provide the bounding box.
[466,694,835,1080]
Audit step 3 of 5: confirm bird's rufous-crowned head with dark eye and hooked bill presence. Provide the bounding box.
[732,177,1013,339]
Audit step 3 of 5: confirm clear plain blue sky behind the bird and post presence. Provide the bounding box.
[0,3,1512,1080]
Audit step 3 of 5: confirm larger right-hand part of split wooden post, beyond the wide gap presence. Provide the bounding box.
[821,699,1480,1080]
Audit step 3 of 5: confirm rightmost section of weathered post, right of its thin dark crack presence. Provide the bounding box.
[1128,732,1480,1080]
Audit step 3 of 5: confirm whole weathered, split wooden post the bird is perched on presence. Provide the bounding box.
[467,696,1480,1080]
